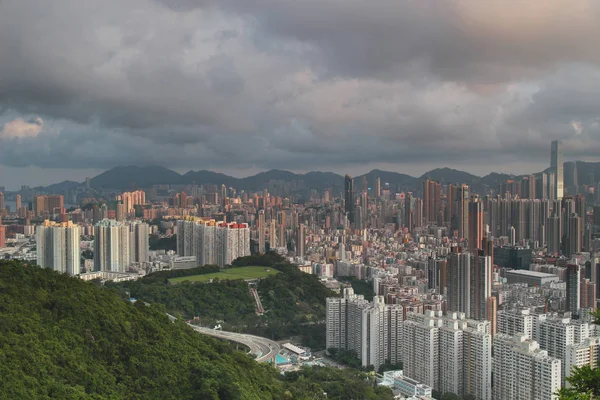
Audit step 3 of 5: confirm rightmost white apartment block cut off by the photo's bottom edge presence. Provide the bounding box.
[493,333,561,400]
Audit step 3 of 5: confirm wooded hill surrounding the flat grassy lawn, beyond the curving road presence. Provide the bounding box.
[107,253,335,349]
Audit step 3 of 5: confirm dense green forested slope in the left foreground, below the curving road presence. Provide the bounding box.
[0,262,392,400]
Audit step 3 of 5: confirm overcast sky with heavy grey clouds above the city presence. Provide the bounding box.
[0,0,600,188]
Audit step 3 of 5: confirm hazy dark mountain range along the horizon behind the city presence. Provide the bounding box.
[39,161,600,192]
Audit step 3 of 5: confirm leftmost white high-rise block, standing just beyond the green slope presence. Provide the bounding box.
[35,220,81,275]
